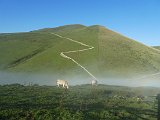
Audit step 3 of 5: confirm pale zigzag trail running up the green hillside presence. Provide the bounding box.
[51,33,97,80]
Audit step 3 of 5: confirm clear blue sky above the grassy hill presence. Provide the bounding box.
[0,0,160,46]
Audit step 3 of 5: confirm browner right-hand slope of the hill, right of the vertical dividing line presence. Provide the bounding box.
[99,27,160,76]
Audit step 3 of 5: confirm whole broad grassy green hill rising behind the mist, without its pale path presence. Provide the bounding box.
[0,24,160,78]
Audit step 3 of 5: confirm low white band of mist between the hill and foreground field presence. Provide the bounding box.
[0,71,160,87]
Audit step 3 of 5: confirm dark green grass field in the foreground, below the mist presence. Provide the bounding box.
[0,84,160,120]
